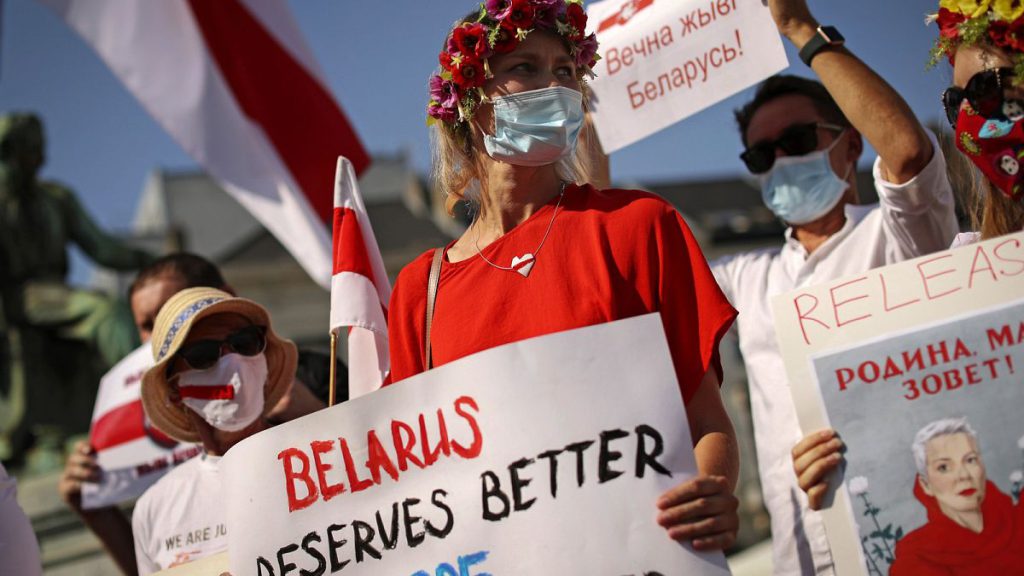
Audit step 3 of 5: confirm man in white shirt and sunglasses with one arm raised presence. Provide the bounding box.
[712,0,957,574]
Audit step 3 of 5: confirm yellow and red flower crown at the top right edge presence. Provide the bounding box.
[929,0,1024,78]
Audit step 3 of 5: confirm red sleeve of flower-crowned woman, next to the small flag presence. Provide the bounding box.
[384,250,433,385]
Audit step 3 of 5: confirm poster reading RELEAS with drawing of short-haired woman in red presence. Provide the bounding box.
[772,234,1024,575]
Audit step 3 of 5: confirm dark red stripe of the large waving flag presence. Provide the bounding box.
[188,0,370,222]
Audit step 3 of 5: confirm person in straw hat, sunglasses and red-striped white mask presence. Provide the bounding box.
[132,288,297,575]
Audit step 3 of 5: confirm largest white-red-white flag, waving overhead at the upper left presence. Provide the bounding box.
[39,0,370,288]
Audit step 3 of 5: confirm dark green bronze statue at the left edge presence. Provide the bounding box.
[0,114,152,467]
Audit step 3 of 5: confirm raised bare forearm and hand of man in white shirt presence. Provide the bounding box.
[766,0,934,184]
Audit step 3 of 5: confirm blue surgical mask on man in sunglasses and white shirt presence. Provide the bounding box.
[758,132,852,224]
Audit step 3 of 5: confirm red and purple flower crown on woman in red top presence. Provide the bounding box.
[427,0,600,126]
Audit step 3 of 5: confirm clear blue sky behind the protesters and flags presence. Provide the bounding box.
[0,0,950,278]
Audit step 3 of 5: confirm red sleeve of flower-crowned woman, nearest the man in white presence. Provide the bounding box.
[655,204,736,403]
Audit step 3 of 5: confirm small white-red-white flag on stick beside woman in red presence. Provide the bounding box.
[331,157,391,398]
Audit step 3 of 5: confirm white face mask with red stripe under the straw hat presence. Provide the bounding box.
[178,354,267,431]
